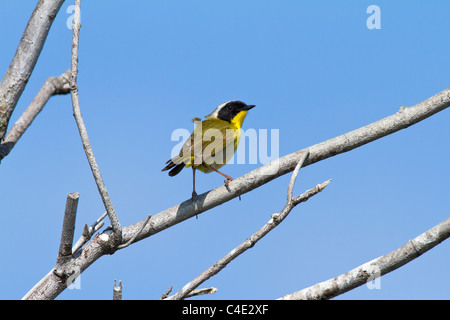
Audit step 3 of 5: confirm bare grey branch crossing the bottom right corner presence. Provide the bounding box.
[279,218,450,300]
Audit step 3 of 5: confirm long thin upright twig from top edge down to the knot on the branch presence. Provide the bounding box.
[70,0,122,241]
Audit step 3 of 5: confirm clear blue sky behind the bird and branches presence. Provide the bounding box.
[0,0,450,299]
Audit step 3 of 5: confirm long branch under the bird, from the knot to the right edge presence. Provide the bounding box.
[122,88,450,246]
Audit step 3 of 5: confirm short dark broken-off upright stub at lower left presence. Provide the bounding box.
[58,192,80,257]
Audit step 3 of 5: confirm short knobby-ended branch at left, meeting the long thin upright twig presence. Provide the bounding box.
[0,70,70,160]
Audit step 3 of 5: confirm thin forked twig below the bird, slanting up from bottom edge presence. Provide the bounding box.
[167,150,331,300]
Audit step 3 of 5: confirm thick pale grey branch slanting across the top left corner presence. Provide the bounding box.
[0,0,64,142]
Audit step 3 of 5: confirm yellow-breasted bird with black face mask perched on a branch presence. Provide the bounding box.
[161,100,255,199]
